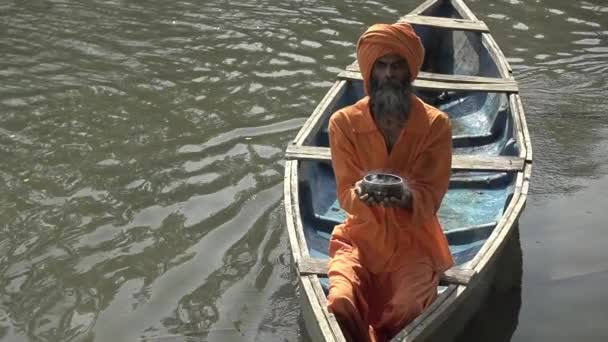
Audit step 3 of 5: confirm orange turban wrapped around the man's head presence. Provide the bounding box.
[357,23,424,95]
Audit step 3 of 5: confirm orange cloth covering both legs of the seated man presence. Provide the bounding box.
[328,243,439,342]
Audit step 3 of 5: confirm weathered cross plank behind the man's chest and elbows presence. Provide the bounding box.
[285,145,524,171]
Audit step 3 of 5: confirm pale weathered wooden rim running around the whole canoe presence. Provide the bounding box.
[284,0,532,341]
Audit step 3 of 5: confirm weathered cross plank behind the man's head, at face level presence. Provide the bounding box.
[338,71,519,93]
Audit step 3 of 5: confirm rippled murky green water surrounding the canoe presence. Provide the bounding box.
[0,0,608,341]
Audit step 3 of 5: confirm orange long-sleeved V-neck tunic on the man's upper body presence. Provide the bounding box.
[329,97,453,273]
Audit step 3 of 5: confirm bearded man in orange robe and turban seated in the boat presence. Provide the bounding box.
[328,23,453,341]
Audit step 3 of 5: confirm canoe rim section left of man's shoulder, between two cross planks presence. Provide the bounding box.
[294,80,346,145]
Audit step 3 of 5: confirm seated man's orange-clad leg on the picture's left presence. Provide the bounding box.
[327,239,369,342]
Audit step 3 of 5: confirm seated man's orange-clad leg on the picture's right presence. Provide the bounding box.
[372,263,439,342]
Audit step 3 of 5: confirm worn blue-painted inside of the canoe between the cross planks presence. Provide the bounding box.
[298,2,519,291]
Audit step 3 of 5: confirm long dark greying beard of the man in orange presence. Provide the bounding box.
[370,79,414,119]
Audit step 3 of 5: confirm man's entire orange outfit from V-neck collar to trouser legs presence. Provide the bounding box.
[328,95,453,340]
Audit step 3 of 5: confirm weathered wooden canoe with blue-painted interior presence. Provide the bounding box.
[284,0,532,341]
